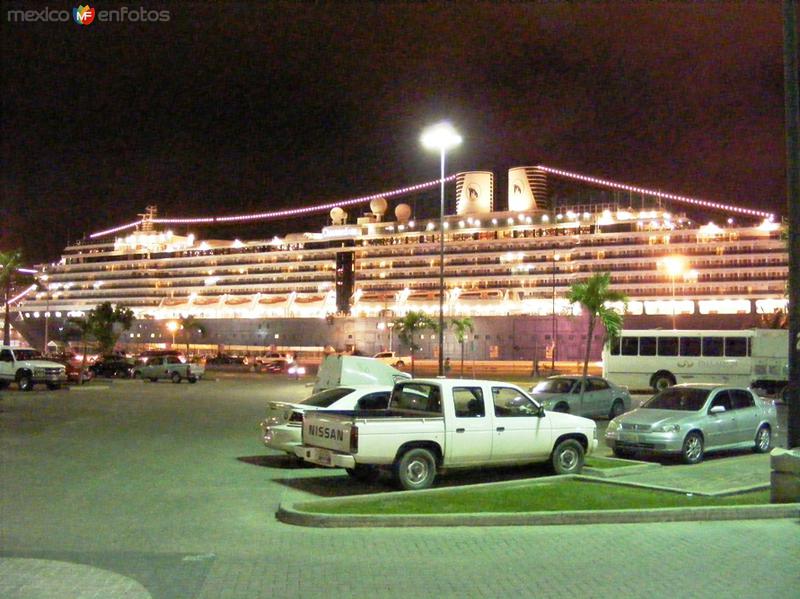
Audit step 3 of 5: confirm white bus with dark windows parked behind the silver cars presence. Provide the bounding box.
[603,329,789,393]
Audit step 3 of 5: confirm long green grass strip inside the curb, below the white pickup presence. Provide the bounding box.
[296,480,769,515]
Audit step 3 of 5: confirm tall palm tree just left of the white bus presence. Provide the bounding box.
[567,272,628,405]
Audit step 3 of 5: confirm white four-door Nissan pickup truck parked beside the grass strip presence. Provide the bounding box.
[295,379,597,490]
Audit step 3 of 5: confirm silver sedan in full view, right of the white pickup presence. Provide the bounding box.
[606,384,778,464]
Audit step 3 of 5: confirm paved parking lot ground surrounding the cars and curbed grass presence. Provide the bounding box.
[0,374,800,598]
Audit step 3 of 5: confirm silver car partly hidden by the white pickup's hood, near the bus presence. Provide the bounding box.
[530,376,631,418]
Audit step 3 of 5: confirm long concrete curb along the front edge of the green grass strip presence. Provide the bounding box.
[276,503,800,528]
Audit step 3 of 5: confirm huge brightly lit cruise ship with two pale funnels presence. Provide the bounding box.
[13,165,788,360]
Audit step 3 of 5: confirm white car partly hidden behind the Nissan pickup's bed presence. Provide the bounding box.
[261,385,392,456]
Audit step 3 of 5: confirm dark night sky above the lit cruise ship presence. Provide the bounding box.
[0,0,786,262]
